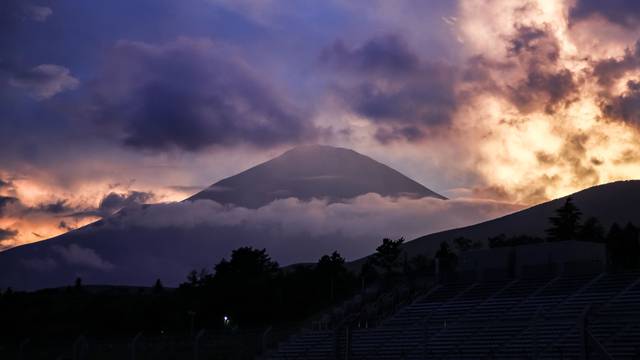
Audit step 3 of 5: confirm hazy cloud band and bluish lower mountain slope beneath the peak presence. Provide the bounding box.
[0,194,520,288]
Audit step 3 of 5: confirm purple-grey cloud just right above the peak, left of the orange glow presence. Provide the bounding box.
[320,35,457,142]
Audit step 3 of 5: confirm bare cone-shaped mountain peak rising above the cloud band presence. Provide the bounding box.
[189,145,445,208]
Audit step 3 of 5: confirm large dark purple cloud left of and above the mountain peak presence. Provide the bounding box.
[93,38,318,151]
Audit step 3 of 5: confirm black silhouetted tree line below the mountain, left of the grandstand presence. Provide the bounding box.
[0,239,433,338]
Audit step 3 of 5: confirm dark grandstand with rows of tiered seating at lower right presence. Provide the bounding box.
[269,242,640,360]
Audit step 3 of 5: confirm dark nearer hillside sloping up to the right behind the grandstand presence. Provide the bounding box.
[405,180,640,256]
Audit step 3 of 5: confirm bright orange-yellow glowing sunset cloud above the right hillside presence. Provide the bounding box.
[442,0,640,203]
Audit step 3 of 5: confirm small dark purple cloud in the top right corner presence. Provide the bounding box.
[569,0,640,27]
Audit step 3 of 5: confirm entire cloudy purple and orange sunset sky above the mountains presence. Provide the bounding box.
[0,0,640,249]
